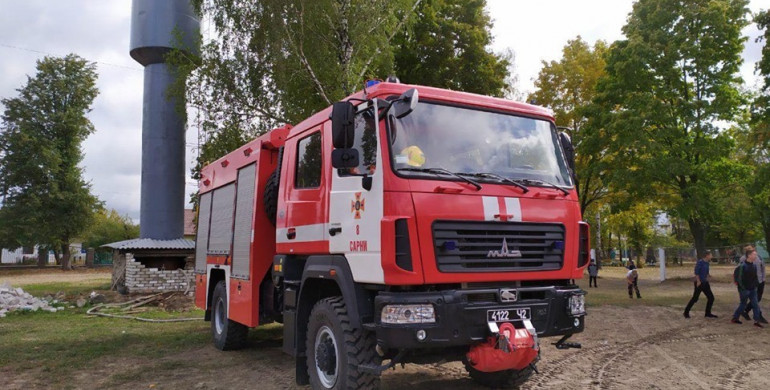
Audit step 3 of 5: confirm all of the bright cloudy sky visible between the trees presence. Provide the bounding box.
[0,0,770,222]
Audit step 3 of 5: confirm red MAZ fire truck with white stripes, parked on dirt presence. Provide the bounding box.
[195,82,589,389]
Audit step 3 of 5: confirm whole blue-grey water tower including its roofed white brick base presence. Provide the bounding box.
[105,0,200,292]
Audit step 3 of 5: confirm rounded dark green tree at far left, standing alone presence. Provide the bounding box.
[0,54,99,270]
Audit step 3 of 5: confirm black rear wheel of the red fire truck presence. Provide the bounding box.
[211,280,249,351]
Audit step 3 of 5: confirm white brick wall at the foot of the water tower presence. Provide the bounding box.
[126,253,195,293]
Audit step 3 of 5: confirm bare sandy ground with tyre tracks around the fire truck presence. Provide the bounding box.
[6,266,770,390]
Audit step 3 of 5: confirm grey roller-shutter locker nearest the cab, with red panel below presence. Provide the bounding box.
[229,163,259,326]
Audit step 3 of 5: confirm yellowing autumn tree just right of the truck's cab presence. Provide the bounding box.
[527,36,610,214]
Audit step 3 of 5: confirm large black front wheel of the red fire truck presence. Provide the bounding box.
[306,297,381,390]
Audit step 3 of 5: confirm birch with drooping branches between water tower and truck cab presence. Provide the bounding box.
[179,0,421,171]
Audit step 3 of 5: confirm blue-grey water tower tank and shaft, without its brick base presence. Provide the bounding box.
[130,0,200,240]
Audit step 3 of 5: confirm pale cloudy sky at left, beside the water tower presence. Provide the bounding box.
[0,0,196,221]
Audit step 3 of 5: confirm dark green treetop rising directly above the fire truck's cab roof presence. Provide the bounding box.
[394,0,513,96]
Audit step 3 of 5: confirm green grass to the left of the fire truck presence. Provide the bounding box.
[0,280,211,388]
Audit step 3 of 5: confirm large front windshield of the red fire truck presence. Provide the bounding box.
[389,102,572,186]
